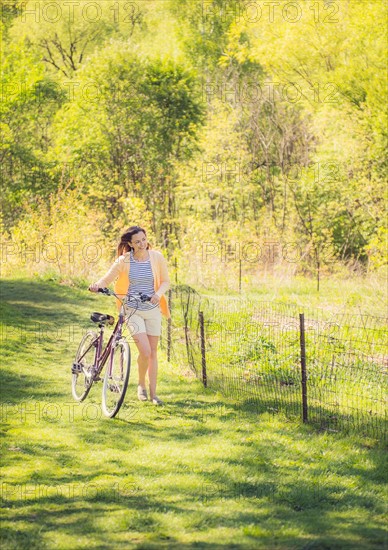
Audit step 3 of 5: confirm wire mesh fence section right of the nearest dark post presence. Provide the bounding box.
[306,312,388,439]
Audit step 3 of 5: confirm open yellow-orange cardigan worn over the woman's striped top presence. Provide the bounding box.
[96,250,171,319]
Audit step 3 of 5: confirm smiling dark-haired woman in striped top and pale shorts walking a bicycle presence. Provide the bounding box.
[89,225,170,405]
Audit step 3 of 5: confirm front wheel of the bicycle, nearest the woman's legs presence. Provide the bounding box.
[102,339,131,418]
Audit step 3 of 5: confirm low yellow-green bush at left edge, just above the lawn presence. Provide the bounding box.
[2,188,113,284]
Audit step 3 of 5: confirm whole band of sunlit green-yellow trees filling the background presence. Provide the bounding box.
[0,0,388,280]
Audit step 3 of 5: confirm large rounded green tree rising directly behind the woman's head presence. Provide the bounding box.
[53,42,203,250]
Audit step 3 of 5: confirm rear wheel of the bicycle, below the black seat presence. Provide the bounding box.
[71,330,98,401]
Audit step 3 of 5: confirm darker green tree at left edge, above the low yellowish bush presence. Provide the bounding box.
[0,33,65,227]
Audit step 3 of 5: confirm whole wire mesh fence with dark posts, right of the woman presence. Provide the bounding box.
[162,285,388,439]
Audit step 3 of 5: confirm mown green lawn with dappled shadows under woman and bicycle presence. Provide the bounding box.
[1,279,387,550]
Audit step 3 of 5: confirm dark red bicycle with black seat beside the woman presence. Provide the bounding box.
[71,288,151,418]
